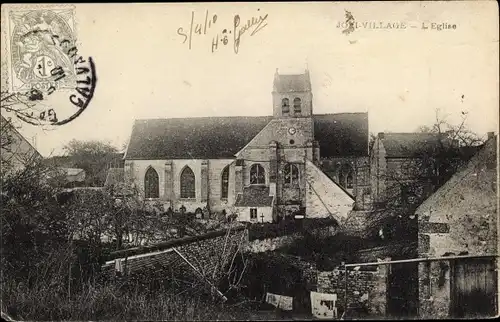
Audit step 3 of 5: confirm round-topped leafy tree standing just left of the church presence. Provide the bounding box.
[64,140,121,187]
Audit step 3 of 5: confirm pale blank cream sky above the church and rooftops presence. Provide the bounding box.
[2,1,499,156]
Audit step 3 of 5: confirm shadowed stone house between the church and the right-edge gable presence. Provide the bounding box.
[370,133,478,213]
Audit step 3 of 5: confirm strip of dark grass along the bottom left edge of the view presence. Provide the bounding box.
[2,278,258,321]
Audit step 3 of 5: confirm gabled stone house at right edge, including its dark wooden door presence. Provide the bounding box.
[416,134,498,318]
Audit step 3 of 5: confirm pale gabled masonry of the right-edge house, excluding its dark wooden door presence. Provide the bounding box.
[416,139,498,318]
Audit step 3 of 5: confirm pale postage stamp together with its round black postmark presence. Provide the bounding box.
[2,5,97,125]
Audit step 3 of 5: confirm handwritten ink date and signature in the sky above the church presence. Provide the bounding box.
[177,9,268,54]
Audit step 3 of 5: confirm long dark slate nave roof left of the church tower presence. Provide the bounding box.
[125,116,271,160]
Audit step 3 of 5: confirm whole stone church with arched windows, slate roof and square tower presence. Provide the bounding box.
[124,70,370,222]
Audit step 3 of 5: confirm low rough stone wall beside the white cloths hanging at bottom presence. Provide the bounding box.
[317,265,387,316]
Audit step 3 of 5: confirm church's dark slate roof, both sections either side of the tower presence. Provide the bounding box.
[125,113,368,160]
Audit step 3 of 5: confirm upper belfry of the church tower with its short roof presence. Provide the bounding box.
[273,69,312,117]
